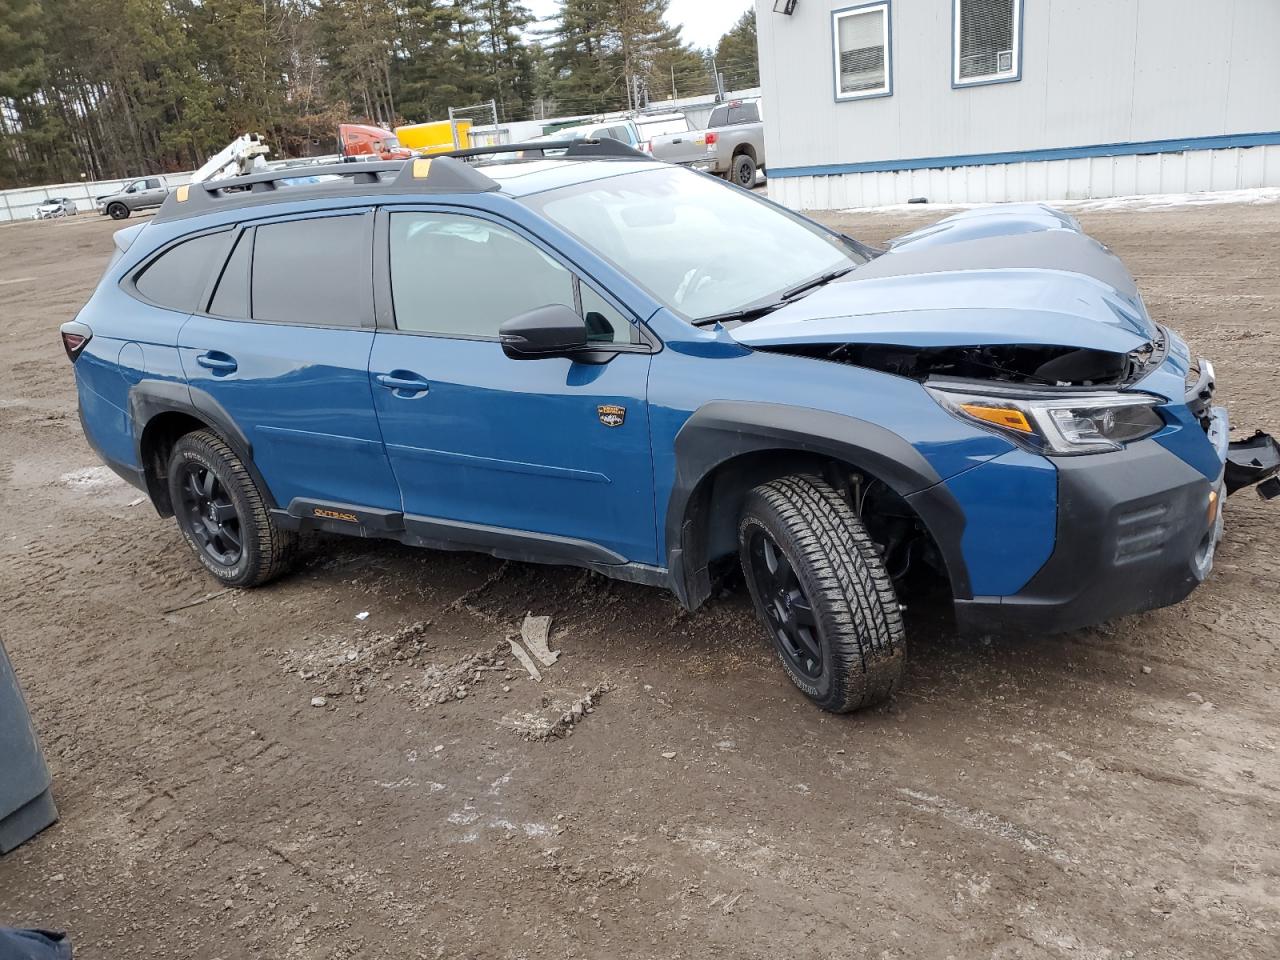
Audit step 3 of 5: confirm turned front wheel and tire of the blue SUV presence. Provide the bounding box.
[739,476,904,713]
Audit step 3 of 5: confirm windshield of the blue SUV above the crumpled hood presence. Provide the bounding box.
[525,166,867,321]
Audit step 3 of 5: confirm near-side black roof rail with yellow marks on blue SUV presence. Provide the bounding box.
[155,156,500,221]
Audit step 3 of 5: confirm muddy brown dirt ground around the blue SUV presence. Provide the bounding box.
[0,197,1280,960]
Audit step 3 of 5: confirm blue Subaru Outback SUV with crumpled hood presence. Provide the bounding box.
[63,141,1280,710]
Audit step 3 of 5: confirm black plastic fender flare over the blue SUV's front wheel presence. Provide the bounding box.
[664,401,970,609]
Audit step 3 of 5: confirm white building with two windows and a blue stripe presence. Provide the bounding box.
[756,0,1280,209]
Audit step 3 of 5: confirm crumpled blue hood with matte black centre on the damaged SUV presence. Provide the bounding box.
[731,205,1157,353]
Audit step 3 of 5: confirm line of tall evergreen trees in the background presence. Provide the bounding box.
[0,0,758,188]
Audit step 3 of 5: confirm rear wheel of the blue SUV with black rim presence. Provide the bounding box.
[168,430,298,586]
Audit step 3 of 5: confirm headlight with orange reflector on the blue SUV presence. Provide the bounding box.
[925,387,1165,457]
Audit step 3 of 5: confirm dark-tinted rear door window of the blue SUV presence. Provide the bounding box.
[249,215,372,326]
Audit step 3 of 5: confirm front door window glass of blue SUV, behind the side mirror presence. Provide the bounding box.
[390,212,631,343]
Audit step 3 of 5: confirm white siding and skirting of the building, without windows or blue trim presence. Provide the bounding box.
[756,0,1280,202]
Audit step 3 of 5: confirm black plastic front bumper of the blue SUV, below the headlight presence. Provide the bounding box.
[956,437,1225,635]
